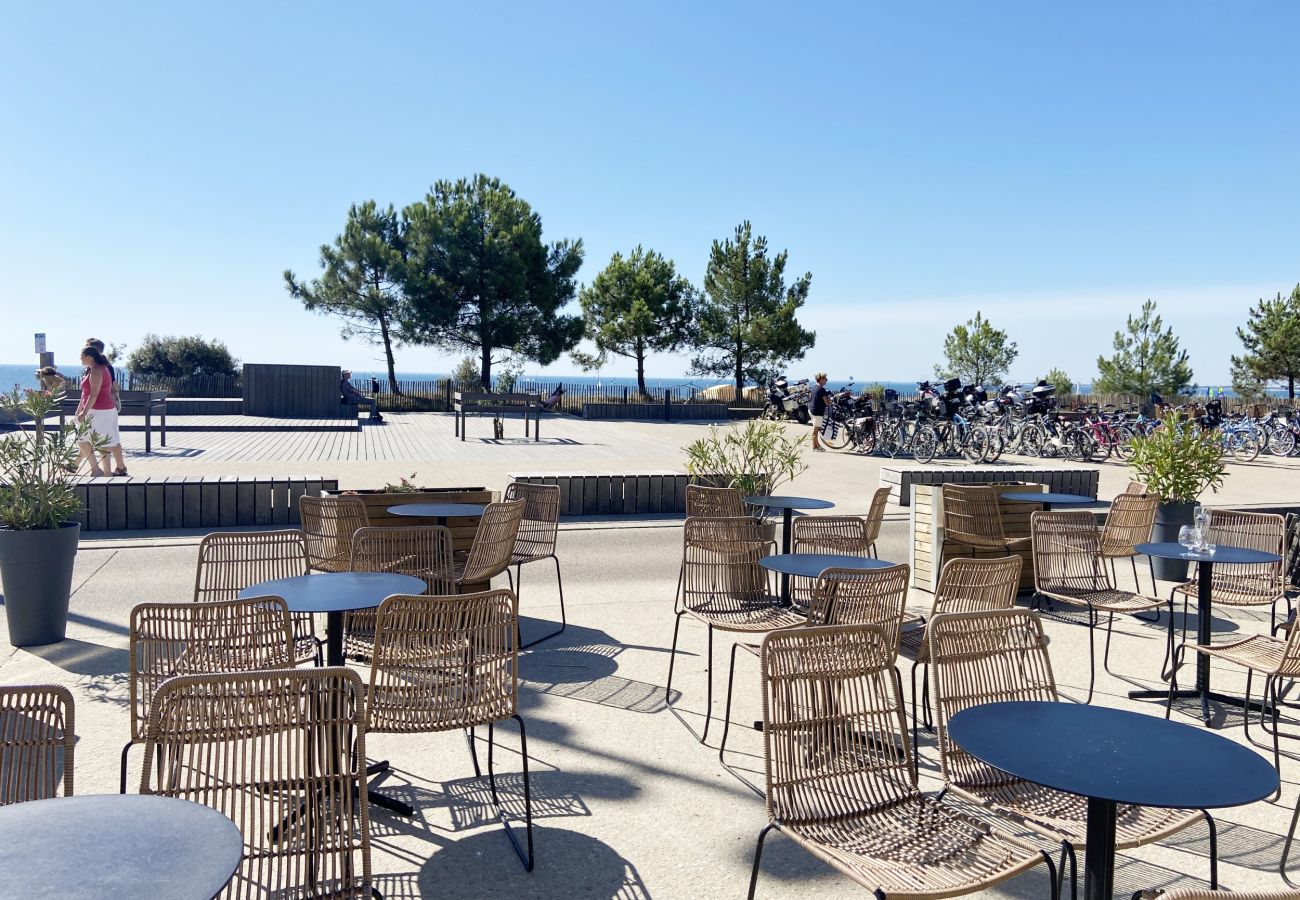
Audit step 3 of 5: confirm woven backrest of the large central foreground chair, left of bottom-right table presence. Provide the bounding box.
[762,626,919,825]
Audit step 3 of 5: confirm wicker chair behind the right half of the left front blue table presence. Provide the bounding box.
[343,525,456,659]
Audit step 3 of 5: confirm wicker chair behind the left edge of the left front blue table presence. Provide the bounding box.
[194,528,324,666]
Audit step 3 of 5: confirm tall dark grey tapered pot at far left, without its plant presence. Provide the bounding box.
[0,522,81,646]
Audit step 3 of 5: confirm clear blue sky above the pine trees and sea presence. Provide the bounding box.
[0,0,1300,384]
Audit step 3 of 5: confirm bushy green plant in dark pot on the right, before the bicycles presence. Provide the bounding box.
[1128,411,1225,581]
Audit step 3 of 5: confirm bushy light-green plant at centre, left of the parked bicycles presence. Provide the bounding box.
[681,419,807,537]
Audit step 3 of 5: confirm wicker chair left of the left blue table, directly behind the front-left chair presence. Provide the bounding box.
[120,597,294,793]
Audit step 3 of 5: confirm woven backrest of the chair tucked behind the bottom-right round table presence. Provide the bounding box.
[926,609,1057,786]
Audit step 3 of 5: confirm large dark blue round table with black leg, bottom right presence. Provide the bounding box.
[948,701,1278,900]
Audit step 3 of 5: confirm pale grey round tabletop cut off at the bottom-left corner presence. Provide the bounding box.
[0,793,243,900]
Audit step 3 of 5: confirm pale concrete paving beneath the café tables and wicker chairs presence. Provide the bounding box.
[0,512,1300,900]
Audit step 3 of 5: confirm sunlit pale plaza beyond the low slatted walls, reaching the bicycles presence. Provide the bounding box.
[86,412,1300,512]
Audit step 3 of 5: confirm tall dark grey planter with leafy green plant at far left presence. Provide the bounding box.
[0,389,99,646]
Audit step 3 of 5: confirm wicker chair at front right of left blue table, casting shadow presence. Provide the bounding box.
[367,590,533,871]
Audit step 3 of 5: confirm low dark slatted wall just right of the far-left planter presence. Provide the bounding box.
[73,475,338,531]
